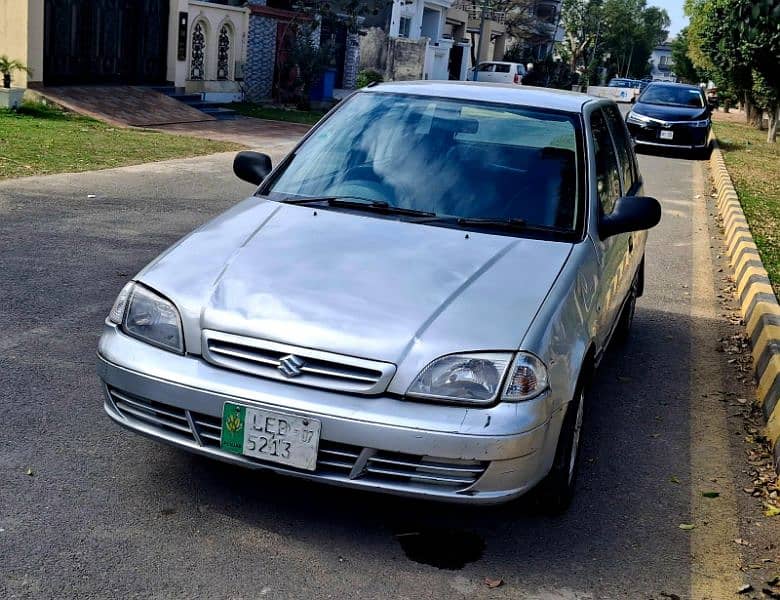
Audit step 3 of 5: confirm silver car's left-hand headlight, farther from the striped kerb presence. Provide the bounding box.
[108,283,184,354]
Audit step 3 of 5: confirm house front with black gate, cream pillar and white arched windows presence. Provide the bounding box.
[0,0,250,100]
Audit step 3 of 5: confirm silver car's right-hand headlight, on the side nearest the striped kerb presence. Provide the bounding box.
[406,352,547,405]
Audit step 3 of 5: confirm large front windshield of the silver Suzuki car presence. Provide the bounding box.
[261,92,579,232]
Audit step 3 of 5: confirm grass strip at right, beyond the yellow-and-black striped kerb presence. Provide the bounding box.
[714,121,780,297]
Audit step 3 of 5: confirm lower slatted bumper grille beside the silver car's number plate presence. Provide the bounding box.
[108,387,489,491]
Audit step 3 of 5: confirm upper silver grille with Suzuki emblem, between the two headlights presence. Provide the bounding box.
[202,330,395,394]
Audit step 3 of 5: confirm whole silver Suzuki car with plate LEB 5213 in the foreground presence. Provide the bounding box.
[98,82,661,510]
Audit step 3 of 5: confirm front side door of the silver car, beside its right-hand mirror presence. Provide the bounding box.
[590,108,630,349]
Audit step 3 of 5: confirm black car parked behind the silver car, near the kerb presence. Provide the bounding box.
[626,82,712,153]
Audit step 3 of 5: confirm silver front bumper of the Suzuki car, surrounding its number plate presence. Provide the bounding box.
[98,325,562,504]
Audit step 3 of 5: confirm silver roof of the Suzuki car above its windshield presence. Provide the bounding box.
[364,81,598,113]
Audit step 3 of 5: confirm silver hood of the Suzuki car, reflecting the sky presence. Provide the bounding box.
[139,198,571,364]
